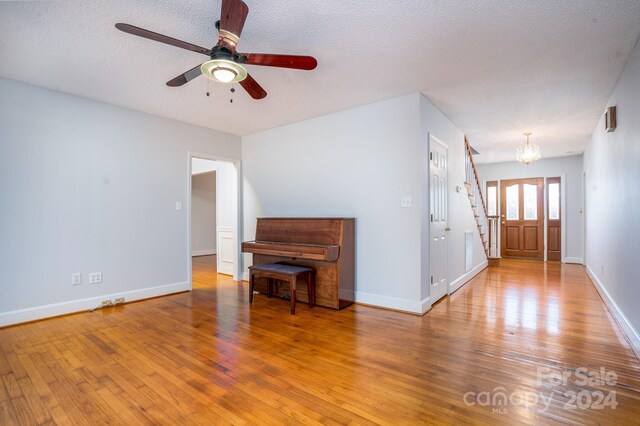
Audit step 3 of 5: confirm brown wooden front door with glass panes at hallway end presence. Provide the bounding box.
[500,178,544,259]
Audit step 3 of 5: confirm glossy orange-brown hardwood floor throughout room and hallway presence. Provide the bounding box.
[0,257,640,425]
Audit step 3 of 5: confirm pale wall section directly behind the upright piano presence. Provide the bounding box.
[242,94,421,311]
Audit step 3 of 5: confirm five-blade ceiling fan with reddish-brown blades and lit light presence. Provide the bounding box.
[116,0,318,99]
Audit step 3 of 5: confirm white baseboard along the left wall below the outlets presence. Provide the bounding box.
[0,281,191,327]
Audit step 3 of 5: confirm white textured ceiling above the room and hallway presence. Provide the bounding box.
[0,0,640,162]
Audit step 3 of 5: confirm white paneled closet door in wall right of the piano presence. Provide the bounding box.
[429,136,449,303]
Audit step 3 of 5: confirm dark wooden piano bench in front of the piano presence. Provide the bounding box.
[249,263,316,315]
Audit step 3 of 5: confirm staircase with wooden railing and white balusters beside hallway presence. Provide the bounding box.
[464,136,500,266]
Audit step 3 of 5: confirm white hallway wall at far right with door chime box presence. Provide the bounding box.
[584,38,640,354]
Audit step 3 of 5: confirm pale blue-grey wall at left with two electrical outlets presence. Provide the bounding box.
[0,79,241,325]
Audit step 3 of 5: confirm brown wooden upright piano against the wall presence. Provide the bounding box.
[242,217,355,309]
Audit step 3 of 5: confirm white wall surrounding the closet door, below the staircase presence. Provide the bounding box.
[420,95,487,305]
